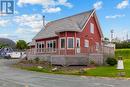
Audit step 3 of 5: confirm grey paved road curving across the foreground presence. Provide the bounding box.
[0,59,130,87]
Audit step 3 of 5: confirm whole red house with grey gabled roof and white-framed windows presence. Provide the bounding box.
[29,10,115,65]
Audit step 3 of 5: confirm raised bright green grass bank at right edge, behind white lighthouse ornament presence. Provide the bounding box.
[115,49,130,59]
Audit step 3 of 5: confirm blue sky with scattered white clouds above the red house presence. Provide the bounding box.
[0,0,130,42]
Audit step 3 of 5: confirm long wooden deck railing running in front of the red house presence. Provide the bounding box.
[27,46,114,55]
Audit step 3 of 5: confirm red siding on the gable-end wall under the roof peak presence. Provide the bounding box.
[77,17,101,51]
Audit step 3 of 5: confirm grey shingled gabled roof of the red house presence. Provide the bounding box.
[33,10,102,40]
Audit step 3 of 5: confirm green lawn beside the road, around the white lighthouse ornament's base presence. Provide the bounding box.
[86,59,130,77]
